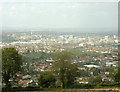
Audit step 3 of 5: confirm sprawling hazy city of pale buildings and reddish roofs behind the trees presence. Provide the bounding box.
[0,32,118,87]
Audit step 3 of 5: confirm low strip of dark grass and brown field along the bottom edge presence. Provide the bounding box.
[2,84,120,92]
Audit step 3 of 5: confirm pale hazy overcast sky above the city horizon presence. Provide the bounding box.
[2,2,118,29]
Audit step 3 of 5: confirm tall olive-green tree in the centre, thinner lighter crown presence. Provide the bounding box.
[52,52,78,88]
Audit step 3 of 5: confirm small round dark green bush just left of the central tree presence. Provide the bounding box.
[38,71,56,88]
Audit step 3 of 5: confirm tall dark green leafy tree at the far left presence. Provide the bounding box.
[2,47,22,87]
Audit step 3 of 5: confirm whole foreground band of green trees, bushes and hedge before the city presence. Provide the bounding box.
[2,48,120,92]
